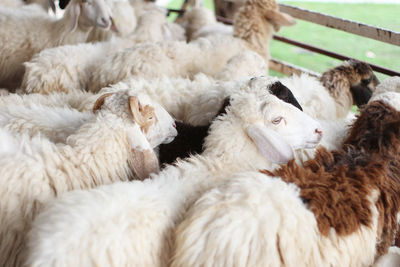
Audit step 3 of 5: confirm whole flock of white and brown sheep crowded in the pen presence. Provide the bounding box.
[0,0,400,267]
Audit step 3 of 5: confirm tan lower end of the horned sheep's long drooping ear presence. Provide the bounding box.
[132,149,160,180]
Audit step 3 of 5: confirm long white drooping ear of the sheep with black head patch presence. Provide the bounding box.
[246,123,294,164]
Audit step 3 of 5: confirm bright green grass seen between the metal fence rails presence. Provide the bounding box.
[271,1,400,79]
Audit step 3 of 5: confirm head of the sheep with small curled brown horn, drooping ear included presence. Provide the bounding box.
[93,90,177,179]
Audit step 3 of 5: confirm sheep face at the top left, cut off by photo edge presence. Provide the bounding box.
[70,0,112,31]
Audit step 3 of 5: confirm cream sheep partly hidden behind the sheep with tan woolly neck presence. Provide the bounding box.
[22,6,188,94]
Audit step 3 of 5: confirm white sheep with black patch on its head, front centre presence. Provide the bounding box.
[26,77,321,266]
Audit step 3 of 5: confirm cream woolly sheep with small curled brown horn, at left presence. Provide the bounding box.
[0,90,177,266]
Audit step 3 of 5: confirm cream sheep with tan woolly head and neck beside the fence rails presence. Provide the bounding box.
[89,0,295,92]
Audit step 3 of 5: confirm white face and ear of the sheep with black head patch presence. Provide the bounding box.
[227,77,322,163]
